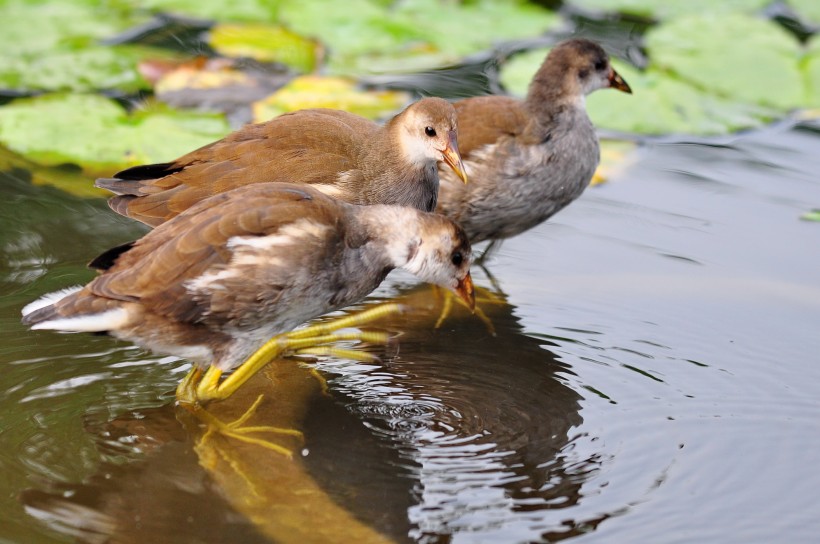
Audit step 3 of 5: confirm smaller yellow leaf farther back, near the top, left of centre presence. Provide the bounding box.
[208,23,324,73]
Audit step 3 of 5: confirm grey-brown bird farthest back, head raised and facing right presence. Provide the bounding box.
[438,39,632,249]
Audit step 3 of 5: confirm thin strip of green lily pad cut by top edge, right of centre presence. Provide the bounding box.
[570,0,772,20]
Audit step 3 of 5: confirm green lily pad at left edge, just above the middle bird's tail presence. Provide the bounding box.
[0,94,230,173]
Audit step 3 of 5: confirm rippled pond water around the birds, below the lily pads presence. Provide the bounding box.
[0,122,820,543]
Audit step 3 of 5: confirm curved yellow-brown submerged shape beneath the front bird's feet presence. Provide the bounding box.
[180,359,398,544]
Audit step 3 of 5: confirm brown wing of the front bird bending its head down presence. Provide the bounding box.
[87,184,340,321]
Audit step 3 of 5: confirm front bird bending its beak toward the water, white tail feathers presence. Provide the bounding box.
[23,183,475,402]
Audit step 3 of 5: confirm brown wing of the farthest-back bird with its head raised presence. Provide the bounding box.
[453,96,527,160]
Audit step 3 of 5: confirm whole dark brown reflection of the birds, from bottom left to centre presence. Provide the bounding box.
[17,278,596,542]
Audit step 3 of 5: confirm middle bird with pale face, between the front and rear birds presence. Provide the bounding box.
[96,98,466,227]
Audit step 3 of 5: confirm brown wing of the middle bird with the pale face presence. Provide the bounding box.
[106,109,381,226]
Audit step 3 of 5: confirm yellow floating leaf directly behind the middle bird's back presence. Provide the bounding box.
[253,76,410,122]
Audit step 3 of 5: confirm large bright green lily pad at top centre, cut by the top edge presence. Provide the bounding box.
[280,0,560,74]
